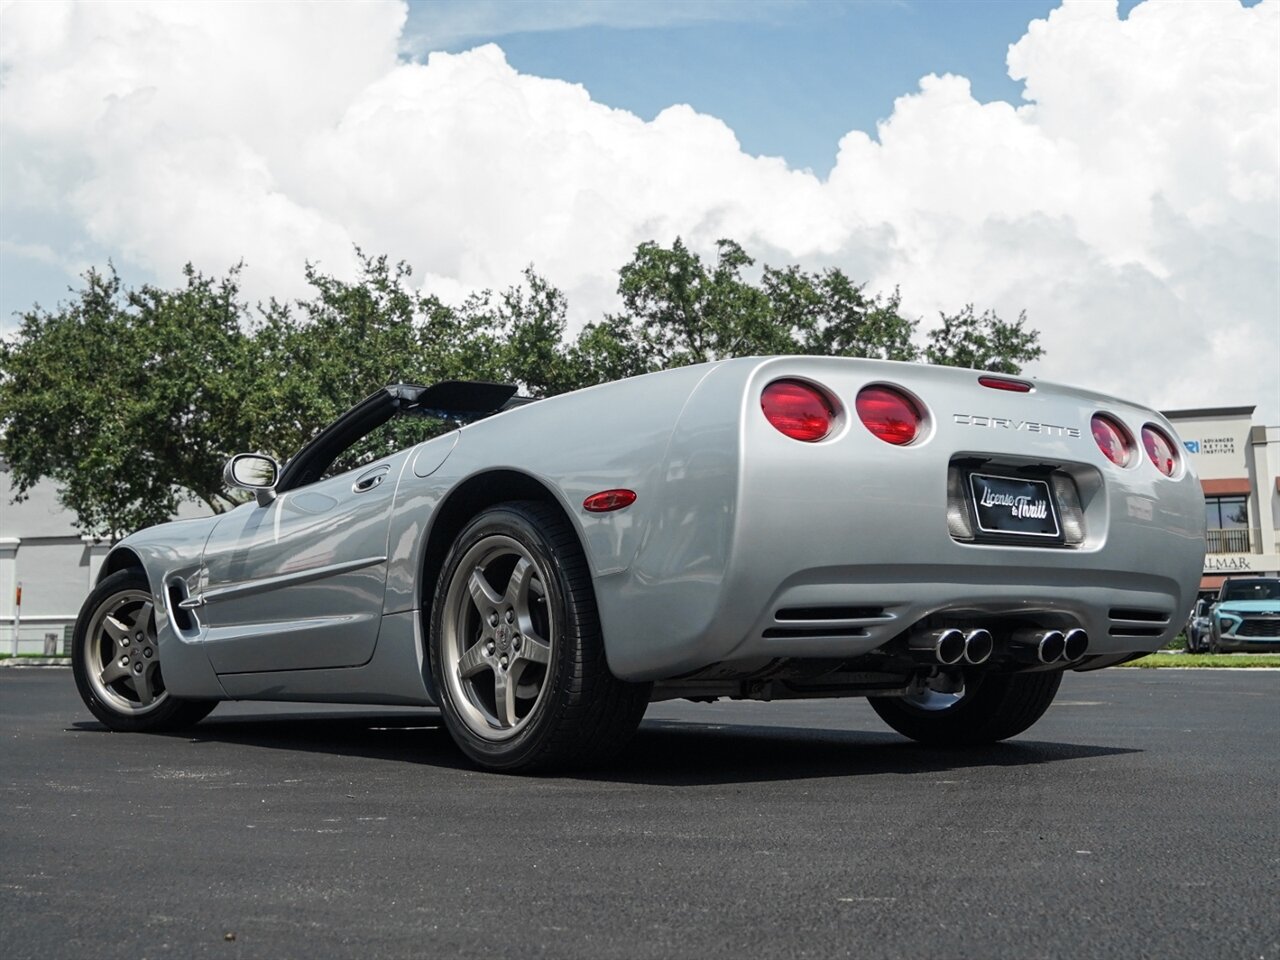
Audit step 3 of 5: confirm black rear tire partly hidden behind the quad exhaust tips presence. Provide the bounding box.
[870,671,1062,746]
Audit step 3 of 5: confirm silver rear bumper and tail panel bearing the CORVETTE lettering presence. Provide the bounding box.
[596,358,1204,680]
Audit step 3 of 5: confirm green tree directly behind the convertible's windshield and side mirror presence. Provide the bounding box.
[236,257,572,470]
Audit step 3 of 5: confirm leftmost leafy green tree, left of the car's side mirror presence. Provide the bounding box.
[0,265,248,536]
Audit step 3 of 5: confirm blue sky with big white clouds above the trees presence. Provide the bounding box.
[0,0,1280,424]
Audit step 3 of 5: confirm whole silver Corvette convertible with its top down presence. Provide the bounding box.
[74,357,1204,771]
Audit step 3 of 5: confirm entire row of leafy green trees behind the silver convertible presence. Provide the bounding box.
[0,239,1042,536]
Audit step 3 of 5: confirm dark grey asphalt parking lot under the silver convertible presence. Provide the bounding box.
[0,669,1280,957]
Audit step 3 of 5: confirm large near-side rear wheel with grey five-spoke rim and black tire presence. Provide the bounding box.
[429,502,650,772]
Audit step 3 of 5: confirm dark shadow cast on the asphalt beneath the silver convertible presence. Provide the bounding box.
[74,710,1139,786]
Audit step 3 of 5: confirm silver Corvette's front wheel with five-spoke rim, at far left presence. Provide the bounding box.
[72,568,218,732]
